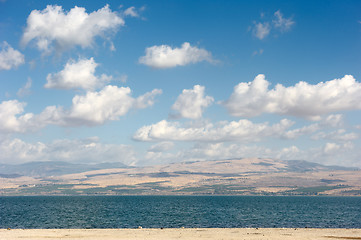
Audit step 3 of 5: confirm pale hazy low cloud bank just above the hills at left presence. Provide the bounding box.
[0,138,137,165]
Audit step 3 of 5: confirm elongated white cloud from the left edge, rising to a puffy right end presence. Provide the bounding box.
[0,85,162,133]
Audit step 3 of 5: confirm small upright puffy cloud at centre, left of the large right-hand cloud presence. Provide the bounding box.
[172,85,214,119]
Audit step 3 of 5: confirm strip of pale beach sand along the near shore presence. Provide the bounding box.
[0,228,361,240]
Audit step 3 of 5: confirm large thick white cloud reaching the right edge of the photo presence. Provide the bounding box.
[222,74,361,120]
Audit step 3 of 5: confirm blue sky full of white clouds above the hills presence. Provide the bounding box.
[0,0,361,167]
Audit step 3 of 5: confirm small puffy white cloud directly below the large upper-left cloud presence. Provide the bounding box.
[44,58,112,90]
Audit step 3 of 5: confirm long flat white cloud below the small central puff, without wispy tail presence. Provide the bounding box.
[133,119,294,142]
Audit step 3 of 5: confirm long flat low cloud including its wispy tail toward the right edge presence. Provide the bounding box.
[133,115,348,142]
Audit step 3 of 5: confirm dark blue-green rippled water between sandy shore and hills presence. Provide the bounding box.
[0,196,361,228]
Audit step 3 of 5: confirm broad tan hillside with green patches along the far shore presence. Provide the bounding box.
[0,158,361,195]
